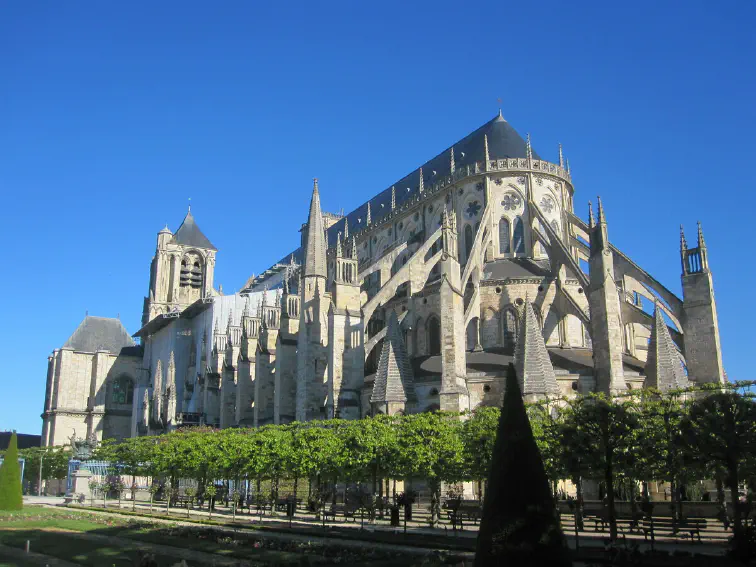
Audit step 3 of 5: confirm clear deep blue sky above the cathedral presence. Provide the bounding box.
[0,0,756,433]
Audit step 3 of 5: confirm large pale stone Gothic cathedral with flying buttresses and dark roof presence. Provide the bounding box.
[42,113,726,445]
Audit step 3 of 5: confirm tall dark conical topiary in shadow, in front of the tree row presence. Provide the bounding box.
[475,364,572,567]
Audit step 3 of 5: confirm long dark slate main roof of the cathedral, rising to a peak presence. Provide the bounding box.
[266,114,541,272]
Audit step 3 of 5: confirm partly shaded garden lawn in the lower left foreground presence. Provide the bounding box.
[0,506,442,567]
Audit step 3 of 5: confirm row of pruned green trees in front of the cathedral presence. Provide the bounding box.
[85,382,756,537]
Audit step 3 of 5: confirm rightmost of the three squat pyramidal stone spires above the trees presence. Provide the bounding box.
[645,300,688,392]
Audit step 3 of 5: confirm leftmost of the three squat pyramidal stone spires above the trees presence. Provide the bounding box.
[370,311,417,404]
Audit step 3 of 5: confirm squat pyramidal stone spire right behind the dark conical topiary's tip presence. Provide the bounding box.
[515,297,559,396]
